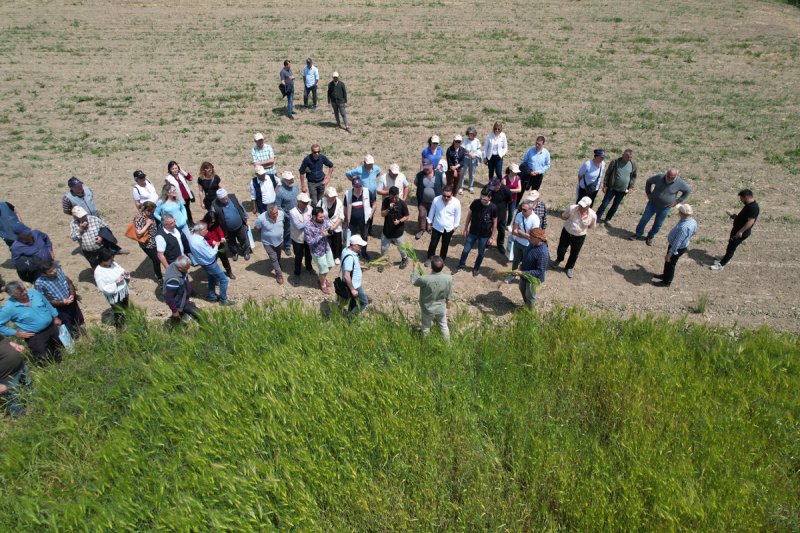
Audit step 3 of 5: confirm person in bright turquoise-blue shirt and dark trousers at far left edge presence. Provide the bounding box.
[0,281,63,364]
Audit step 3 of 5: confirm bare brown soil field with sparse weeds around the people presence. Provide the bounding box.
[0,0,800,332]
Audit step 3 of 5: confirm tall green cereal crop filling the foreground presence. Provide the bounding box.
[0,303,800,531]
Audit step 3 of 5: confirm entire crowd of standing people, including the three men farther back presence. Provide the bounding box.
[0,112,759,415]
